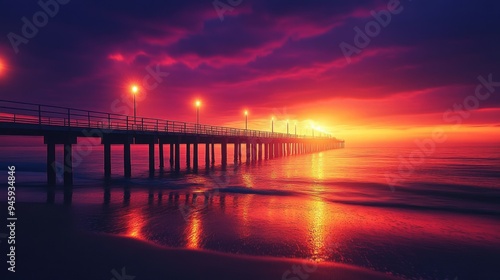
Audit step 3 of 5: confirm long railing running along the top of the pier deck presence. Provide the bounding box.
[0,100,332,138]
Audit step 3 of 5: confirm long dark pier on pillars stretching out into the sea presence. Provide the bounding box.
[0,100,345,186]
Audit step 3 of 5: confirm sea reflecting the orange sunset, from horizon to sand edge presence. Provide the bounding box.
[0,143,500,279]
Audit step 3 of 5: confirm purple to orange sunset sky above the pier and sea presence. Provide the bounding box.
[0,0,500,145]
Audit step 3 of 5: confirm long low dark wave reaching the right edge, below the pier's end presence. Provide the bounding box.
[208,182,500,216]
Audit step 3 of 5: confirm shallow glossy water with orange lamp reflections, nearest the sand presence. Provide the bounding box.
[51,182,500,275]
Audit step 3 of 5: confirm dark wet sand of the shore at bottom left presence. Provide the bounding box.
[6,203,395,280]
